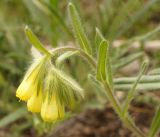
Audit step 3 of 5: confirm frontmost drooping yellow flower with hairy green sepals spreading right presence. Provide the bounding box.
[41,66,82,122]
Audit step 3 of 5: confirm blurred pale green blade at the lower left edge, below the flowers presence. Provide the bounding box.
[0,107,28,128]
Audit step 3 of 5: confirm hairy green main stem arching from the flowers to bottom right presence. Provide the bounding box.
[51,47,145,137]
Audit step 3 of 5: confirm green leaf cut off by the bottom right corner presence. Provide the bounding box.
[148,105,160,137]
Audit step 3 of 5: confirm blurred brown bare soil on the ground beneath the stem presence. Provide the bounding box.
[49,103,160,137]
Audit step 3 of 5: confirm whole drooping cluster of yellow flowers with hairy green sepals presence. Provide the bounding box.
[16,56,83,122]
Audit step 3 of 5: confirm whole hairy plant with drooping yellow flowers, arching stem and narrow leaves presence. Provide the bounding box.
[16,3,160,137]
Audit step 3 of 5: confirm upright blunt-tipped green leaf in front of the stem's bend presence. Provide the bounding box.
[96,40,108,81]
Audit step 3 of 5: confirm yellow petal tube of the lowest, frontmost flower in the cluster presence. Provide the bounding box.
[41,95,64,122]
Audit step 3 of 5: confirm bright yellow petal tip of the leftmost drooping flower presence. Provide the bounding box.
[16,80,35,101]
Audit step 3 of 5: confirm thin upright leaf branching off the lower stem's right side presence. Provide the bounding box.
[122,62,148,115]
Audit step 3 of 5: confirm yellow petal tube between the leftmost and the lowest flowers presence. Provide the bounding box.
[27,90,42,113]
